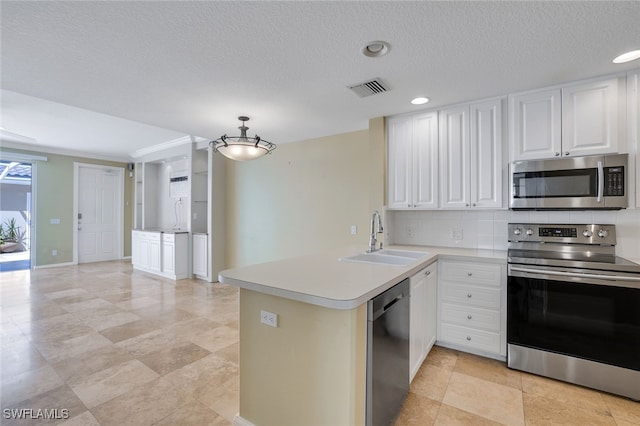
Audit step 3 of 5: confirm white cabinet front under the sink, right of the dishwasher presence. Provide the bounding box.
[409,263,438,380]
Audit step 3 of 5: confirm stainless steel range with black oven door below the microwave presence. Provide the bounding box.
[507,223,640,400]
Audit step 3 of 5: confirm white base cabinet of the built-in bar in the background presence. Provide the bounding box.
[131,231,189,280]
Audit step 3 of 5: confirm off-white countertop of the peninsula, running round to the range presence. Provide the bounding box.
[218,246,507,309]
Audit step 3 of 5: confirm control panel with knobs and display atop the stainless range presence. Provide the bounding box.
[508,223,616,245]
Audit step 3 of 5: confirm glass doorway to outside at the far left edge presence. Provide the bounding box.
[0,160,33,272]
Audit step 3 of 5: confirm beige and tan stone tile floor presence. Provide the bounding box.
[0,262,640,426]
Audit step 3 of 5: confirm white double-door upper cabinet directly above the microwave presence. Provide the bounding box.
[509,77,625,161]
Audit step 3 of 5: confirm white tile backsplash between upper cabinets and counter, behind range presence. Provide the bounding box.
[385,209,640,259]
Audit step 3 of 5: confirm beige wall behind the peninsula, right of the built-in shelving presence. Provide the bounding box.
[226,118,385,267]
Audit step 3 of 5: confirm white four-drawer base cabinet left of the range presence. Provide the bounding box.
[438,260,507,358]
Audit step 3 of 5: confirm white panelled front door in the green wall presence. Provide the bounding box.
[76,165,123,263]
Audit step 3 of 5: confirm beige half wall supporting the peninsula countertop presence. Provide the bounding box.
[240,289,367,426]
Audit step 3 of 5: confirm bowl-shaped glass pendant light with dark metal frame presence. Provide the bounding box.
[209,116,276,161]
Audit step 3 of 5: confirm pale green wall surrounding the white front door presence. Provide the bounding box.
[2,148,133,266]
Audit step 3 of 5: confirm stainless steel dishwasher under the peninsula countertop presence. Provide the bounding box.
[366,279,411,426]
